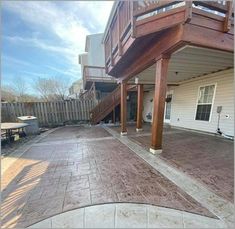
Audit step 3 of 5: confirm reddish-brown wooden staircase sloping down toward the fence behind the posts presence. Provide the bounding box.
[90,85,136,125]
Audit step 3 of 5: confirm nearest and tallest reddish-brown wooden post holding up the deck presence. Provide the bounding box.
[150,57,169,154]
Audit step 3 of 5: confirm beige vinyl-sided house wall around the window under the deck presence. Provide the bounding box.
[143,69,234,136]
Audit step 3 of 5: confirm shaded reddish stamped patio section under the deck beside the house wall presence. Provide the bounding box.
[130,128,234,202]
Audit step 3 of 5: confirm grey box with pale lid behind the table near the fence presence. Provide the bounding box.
[17,116,39,135]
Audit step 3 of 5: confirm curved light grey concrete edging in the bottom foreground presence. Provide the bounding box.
[28,203,226,228]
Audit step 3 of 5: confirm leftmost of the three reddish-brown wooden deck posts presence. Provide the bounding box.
[121,82,127,135]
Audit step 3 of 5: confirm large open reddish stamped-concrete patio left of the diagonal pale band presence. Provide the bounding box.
[1,127,213,228]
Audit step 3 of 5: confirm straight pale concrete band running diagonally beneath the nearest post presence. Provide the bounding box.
[103,126,235,228]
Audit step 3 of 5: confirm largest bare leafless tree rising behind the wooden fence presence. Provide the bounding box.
[35,78,68,101]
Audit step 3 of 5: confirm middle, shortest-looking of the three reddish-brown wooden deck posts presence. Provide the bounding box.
[136,84,144,132]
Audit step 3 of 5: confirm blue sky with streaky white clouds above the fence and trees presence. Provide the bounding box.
[1,1,113,94]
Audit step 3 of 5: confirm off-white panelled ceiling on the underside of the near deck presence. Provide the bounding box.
[130,46,234,84]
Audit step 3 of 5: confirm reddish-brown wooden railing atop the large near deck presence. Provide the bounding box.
[104,0,233,72]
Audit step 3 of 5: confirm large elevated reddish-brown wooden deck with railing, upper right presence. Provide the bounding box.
[104,1,234,81]
